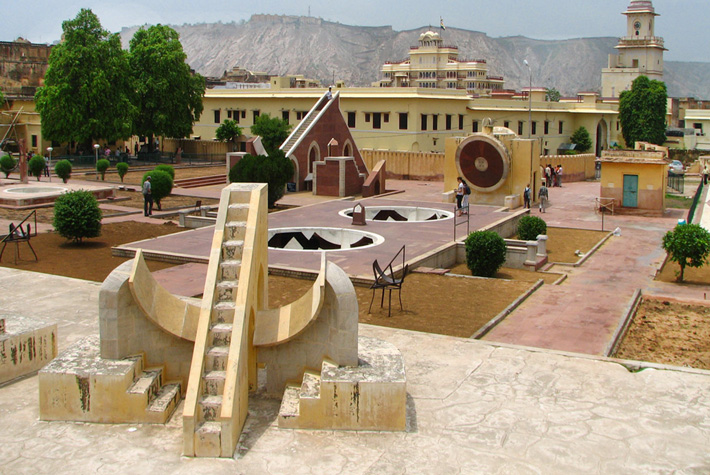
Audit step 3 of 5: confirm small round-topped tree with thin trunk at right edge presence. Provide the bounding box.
[663,224,710,282]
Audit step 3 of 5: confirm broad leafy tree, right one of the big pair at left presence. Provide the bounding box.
[129,25,205,151]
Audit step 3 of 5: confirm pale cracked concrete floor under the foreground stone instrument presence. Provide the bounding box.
[0,268,710,474]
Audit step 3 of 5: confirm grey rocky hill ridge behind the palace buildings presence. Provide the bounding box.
[121,15,710,99]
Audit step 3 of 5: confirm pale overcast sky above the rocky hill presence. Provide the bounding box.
[5,0,710,62]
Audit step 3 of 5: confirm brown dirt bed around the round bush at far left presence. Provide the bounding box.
[0,221,184,282]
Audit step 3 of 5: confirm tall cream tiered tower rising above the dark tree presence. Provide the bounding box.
[602,0,667,97]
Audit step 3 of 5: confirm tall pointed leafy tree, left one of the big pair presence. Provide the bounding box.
[35,9,135,150]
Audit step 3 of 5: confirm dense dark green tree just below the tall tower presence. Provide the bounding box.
[619,76,668,148]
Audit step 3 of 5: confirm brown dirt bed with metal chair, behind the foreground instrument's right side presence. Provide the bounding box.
[269,273,531,338]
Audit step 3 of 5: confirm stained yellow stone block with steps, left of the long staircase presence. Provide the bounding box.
[39,337,182,424]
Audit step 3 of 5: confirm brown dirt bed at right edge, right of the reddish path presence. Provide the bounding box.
[614,299,710,369]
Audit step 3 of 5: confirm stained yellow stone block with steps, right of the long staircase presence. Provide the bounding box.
[278,337,407,430]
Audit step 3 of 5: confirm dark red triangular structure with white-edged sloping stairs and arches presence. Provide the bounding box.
[281,92,368,196]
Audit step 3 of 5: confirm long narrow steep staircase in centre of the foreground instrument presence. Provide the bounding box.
[183,184,266,457]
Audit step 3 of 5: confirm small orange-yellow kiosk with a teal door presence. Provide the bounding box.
[599,150,668,215]
